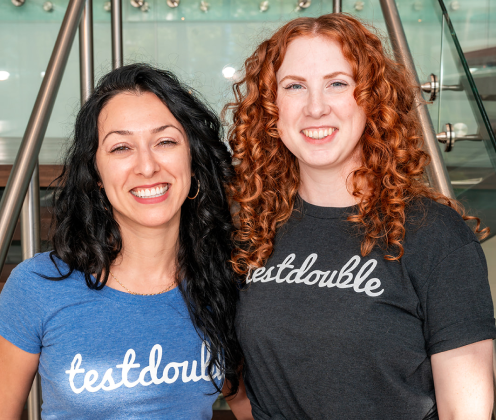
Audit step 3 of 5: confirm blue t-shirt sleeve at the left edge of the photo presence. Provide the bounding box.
[0,266,43,354]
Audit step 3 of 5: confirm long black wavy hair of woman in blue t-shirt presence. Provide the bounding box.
[50,64,242,394]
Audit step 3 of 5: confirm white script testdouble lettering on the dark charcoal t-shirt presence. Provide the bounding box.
[246,254,384,297]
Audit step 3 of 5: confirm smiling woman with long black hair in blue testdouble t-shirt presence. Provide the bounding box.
[0,64,248,420]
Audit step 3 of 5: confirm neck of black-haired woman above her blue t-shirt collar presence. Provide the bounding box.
[107,214,180,294]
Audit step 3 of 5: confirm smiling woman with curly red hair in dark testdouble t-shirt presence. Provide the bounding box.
[226,14,496,420]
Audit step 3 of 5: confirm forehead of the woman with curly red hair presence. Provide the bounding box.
[277,36,353,80]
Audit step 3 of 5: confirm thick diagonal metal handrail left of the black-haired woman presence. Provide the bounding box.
[0,0,84,267]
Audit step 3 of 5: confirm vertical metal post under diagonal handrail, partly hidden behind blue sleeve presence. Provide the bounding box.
[21,164,41,420]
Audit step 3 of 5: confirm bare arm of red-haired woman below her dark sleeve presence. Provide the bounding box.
[431,340,493,420]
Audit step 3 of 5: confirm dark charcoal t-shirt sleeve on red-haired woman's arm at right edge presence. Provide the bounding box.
[421,241,496,355]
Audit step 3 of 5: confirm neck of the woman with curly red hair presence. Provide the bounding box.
[298,160,357,207]
